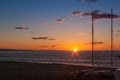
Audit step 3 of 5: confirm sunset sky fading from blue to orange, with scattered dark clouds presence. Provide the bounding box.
[0,0,120,50]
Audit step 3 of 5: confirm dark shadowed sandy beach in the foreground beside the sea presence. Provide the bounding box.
[0,61,114,80]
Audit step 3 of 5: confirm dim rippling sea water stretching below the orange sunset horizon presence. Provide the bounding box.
[0,50,120,67]
